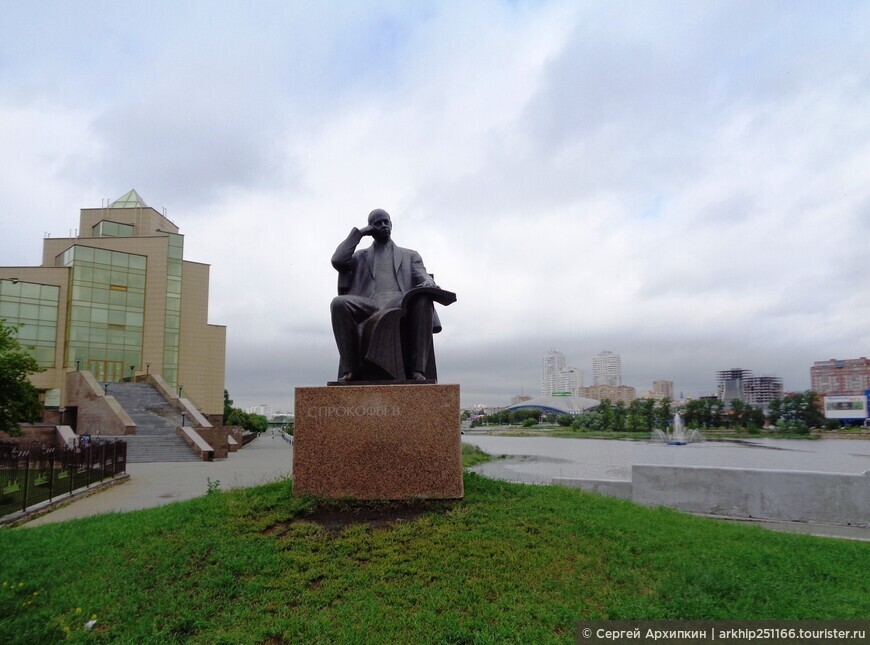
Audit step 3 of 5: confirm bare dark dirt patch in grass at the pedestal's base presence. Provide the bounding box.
[289,499,456,534]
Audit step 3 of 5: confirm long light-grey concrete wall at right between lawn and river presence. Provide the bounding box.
[631,465,870,527]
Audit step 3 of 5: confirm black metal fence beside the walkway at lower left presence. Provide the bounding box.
[0,440,127,517]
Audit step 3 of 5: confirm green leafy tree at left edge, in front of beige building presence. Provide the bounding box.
[0,320,43,436]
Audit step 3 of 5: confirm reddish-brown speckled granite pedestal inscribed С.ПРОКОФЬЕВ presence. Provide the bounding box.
[293,385,463,500]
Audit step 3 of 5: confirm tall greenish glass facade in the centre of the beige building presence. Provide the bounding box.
[57,245,147,382]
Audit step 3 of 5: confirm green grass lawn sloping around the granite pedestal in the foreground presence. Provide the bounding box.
[0,473,870,643]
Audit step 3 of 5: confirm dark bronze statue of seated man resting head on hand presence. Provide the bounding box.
[331,208,456,383]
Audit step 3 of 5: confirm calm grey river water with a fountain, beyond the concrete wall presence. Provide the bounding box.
[462,434,870,483]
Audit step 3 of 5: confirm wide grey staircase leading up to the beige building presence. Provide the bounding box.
[108,383,199,464]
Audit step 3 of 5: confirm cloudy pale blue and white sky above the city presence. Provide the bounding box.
[0,0,870,409]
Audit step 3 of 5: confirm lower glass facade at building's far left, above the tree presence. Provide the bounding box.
[0,280,60,367]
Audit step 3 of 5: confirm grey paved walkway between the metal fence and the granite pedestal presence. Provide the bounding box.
[22,433,293,526]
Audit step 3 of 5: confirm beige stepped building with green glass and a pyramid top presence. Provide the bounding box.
[0,190,226,423]
